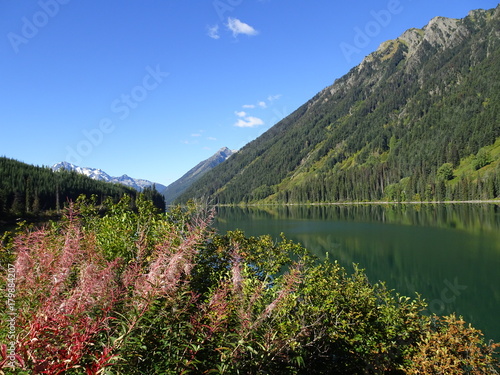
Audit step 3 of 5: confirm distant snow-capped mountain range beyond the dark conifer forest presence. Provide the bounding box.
[52,161,167,193]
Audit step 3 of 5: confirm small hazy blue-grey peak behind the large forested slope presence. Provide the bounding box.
[162,147,237,204]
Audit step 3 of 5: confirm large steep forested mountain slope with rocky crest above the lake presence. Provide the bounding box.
[179,6,500,203]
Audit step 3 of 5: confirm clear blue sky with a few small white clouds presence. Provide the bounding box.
[0,0,498,184]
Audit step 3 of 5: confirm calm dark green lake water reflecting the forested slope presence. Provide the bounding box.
[215,204,500,342]
